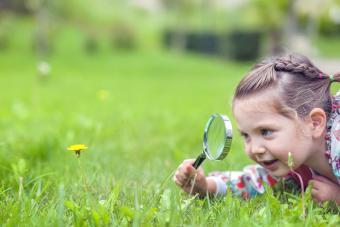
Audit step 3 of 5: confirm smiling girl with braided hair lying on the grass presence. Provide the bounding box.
[174,54,340,204]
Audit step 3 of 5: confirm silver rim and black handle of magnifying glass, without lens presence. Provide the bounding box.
[192,114,233,169]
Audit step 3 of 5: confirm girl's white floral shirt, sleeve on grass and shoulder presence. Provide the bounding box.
[208,91,340,199]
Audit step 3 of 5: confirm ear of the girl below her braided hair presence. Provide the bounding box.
[308,108,327,138]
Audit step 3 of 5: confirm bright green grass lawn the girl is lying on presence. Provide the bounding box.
[0,19,340,226]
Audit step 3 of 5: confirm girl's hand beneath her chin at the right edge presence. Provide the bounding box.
[309,176,340,205]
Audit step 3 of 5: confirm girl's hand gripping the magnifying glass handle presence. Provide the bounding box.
[173,159,208,197]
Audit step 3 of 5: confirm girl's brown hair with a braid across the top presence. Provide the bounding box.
[234,54,340,118]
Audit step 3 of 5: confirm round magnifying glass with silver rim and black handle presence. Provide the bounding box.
[192,114,233,169]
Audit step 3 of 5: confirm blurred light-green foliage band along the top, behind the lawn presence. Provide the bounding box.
[0,0,340,53]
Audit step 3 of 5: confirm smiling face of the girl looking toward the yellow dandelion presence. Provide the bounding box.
[233,92,312,177]
